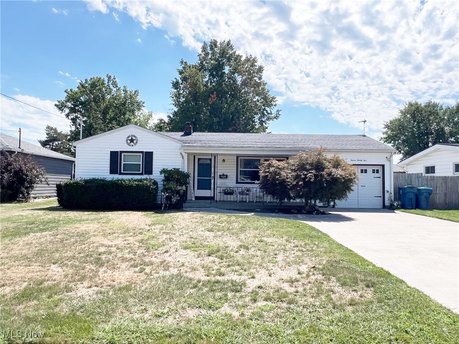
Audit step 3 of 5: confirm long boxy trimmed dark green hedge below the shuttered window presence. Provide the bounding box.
[56,178,158,210]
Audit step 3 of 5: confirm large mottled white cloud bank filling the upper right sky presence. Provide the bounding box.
[88,0,459,130]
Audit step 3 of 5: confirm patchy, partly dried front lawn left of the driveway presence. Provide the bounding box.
[0,201,459,343]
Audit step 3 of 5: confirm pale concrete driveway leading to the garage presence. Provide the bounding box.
[304,210,459,313]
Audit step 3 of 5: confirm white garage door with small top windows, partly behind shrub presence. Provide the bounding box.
[336,165,383,208]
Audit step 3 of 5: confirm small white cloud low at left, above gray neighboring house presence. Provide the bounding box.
[0,95,70,144]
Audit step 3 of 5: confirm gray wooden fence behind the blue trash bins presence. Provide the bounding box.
[394,173,459,209]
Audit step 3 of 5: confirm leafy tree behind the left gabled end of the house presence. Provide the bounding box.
[56,75,151,141]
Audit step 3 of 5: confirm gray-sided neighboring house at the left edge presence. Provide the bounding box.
[0,134,75,197]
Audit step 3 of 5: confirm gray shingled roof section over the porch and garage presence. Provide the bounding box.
[161,132,394,151]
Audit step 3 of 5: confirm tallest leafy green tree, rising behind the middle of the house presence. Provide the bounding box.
[168,40,280,132]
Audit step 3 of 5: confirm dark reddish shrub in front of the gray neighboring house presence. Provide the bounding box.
[0,151,46,202]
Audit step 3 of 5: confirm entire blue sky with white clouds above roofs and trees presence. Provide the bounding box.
[1,0,459,142]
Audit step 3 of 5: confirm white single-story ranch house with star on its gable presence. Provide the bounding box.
[74,125,395,208]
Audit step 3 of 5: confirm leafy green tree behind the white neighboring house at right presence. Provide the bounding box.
[382,101,459,159]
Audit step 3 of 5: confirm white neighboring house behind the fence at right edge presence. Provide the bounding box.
[398,143,459,176]
